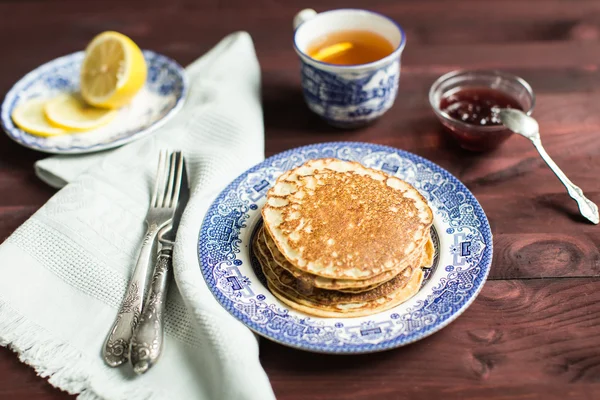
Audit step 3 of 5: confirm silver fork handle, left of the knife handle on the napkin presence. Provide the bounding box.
[102,223,160,367]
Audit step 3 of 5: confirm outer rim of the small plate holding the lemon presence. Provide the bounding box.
[0,49,189,155]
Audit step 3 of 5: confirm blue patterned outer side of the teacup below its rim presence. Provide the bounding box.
[301,60,400,127]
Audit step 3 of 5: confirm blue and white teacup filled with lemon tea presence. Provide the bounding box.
[294,9,406,128]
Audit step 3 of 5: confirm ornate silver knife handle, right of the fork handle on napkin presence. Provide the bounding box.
[130,246,172,374]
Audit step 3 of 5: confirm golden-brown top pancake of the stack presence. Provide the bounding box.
[262,159,433,280]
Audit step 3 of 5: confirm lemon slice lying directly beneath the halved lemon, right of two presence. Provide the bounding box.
[44,94,117,131]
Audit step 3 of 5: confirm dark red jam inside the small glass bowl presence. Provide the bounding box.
[440,88,523,151]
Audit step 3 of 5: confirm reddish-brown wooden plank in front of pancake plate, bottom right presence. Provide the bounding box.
[261,279,600,400]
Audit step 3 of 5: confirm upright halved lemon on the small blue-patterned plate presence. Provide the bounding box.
[81,31,147,109]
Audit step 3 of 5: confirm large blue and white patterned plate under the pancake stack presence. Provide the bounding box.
[198,142,492,353]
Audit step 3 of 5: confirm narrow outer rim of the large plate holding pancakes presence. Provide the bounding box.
[196,141,493,355]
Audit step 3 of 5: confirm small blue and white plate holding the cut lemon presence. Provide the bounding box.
[0,50,187,154]
